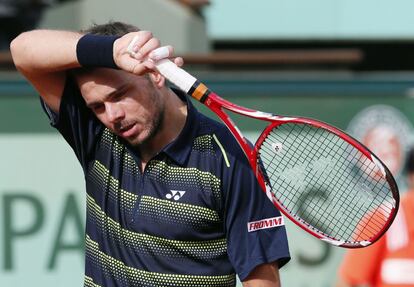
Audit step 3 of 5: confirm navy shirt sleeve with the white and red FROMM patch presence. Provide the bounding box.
[225,143,290,281]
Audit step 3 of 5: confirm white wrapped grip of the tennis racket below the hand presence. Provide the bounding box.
[155,59,197,94]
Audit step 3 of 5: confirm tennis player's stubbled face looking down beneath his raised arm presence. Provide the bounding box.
[76,68,164,146]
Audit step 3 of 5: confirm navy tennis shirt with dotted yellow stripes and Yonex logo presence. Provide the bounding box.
[43,78,290,287]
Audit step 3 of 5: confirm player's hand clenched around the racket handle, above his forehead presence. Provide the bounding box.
[113,31,183,75]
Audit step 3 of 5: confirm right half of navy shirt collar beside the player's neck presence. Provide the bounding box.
[163,89,199,166]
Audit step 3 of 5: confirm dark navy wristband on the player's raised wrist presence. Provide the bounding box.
[76,34,120,69]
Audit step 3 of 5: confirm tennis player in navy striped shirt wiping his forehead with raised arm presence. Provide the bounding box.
[11,23,290,287]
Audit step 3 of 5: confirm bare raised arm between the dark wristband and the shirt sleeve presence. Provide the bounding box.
[10,30,82,112]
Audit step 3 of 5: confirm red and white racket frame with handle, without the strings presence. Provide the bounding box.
[150,57,399,248]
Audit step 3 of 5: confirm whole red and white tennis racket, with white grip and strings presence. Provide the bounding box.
[137,46,399,248]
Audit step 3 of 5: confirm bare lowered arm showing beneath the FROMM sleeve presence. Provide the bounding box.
[242,262,280,287]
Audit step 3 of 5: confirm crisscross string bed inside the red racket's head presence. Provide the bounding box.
[259,123,394,245]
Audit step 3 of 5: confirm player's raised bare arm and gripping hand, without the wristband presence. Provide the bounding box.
[10,30,173,112]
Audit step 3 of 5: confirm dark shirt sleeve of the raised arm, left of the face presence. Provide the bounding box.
[40,76,103,171]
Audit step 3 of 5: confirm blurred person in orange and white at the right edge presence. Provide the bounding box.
[336,149,414,287]
